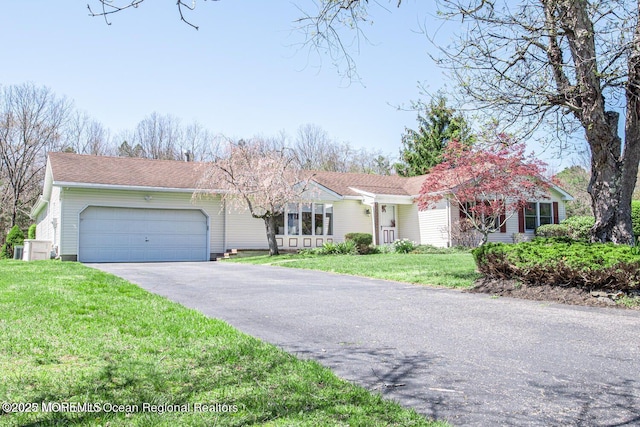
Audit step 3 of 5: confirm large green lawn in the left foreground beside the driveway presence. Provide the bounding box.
[0,261,446,427]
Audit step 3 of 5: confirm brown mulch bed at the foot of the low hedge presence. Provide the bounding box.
[466,278,640,310]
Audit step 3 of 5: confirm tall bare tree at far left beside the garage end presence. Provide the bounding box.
[0,83,71,232]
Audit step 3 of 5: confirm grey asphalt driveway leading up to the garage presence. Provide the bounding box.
[91,263,640,426]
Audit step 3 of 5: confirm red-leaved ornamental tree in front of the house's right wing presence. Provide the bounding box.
[418,138,549,245]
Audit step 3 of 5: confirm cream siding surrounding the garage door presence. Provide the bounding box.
[57,187,224,259]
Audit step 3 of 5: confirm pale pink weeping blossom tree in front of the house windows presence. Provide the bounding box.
[194,140,310,255]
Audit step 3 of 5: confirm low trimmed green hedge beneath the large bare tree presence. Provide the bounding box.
[472,238,640,290]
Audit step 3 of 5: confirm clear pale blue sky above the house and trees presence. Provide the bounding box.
[0,0,566,172]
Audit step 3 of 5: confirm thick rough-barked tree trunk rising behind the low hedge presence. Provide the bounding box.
[561,0,640,245]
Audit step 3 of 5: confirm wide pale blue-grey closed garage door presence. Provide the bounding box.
[78,206,209,262]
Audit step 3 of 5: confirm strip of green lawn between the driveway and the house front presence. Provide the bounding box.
[231,252,480,288]
